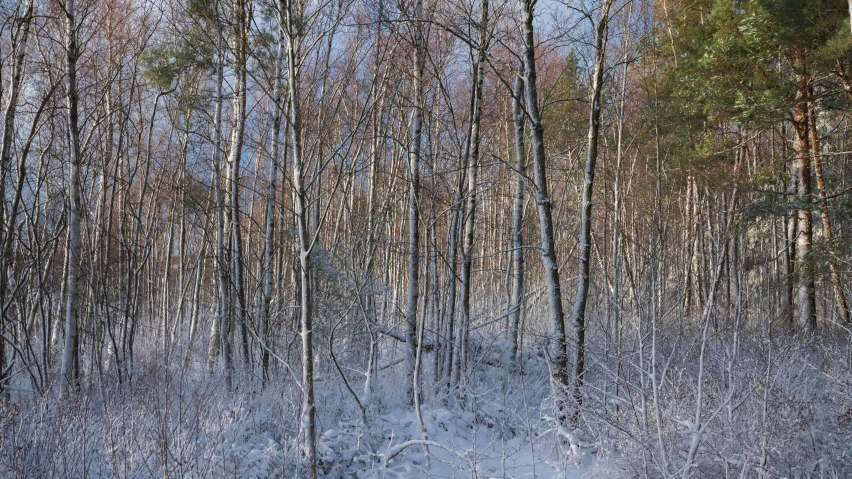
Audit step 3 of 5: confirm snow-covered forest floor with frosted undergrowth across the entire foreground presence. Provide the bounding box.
[0,326,852,479]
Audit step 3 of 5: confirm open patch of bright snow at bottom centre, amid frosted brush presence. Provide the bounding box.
[320,407,608,479]
